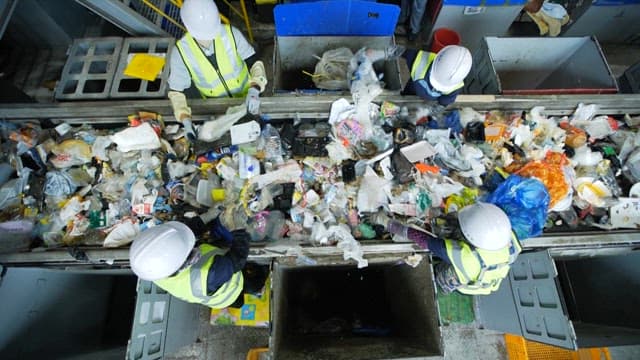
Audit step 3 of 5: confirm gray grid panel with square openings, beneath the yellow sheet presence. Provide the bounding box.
[110,37,176,98]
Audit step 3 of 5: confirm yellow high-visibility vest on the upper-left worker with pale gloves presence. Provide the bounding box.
[176,25,249,97]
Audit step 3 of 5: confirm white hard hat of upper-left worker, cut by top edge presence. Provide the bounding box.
[180,0,222,40]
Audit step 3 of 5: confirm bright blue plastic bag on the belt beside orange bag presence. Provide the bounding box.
[484,175,551,241]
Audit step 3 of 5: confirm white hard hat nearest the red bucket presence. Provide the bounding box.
[429,45,471,93]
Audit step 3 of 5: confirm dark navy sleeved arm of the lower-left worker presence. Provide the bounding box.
[207,230,249,294]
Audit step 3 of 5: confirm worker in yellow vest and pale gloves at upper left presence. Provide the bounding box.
[168,0,267,141]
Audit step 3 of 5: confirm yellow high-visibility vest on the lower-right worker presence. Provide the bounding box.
[445,233,522,295]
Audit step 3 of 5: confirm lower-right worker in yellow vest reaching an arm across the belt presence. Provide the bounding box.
[372,203,522,295]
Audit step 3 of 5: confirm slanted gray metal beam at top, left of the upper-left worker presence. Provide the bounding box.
[76,0,171,36]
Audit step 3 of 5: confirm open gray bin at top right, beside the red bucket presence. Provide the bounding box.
[465,37,618,95]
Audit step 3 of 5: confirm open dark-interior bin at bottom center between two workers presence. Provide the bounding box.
[270,260,443,360]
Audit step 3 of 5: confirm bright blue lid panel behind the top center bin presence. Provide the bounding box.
[273,0,400,36]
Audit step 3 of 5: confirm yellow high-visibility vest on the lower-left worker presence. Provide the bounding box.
[154,244,244,309]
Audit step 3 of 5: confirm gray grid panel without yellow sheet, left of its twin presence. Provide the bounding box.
[55,37,122,100]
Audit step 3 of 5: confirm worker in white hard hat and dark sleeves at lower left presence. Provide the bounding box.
[129,213,249,309]
